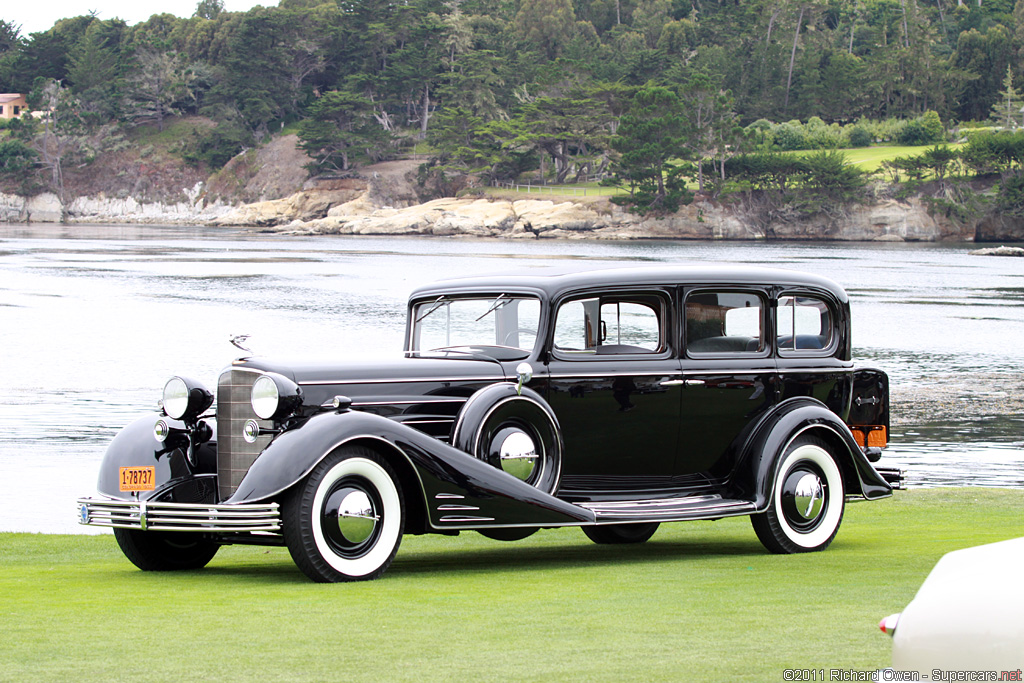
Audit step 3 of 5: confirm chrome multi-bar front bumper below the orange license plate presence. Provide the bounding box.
[78,498,281,533]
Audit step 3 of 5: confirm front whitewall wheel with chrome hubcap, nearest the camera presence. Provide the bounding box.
[283,446,404,583]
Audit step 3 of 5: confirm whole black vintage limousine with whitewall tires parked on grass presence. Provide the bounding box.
[79,267,900,582]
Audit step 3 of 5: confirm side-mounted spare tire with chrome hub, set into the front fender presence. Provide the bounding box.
[452,383,562,494]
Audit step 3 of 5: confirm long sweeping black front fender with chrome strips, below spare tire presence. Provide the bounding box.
[226,411,594,529]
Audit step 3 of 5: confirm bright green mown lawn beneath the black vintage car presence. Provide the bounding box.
[0,488,1024,681]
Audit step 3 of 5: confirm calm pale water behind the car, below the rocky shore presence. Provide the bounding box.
[0,225,1024,532]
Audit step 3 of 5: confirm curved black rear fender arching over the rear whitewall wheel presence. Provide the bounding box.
[741,396,892,512]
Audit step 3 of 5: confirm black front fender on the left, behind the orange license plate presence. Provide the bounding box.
[96,413,216,500]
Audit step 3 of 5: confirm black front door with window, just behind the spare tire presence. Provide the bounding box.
[547,290,682,492]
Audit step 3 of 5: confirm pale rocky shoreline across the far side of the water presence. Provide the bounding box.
[0,156,1024,241]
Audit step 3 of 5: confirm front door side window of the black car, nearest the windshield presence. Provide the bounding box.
[554,296,667,355]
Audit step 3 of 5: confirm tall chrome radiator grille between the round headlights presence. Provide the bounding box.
[217,369,273,501]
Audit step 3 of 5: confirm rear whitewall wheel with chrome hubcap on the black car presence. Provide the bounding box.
[751,436,846,553]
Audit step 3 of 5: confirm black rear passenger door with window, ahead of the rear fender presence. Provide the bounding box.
[676,287,777,484]
